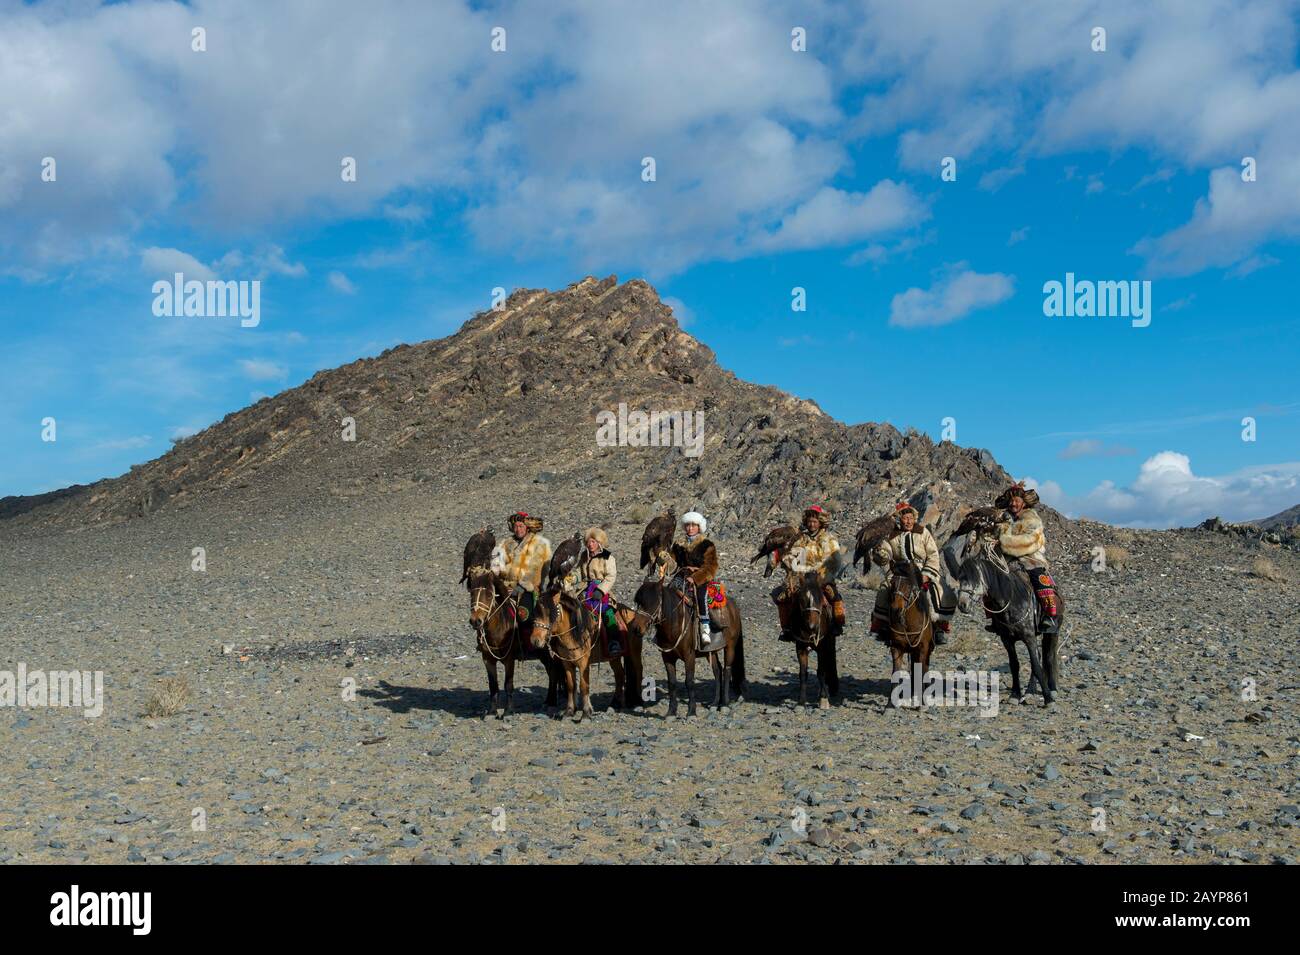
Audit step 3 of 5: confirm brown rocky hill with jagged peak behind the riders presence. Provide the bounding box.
[0,277,1029,534]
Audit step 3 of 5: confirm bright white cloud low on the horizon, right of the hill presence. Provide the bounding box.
[1037,451,1300,528]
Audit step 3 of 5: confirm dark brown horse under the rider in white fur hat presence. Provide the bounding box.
[634,574,745,716]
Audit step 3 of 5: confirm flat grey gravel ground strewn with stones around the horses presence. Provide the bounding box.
[0,490,1300,864]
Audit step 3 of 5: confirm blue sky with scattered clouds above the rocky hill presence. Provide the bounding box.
[0,0,1300,526]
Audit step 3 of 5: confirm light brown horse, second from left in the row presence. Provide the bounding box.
[529,587,644,722]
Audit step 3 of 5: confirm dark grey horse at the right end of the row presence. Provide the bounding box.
[957,539,1065,706]
